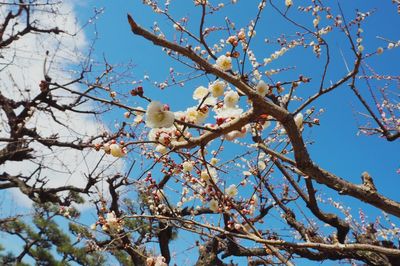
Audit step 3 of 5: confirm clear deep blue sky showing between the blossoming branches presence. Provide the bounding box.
[70,0,400,265]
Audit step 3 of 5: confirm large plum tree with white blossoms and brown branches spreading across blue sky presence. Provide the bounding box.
[0,0,400,265]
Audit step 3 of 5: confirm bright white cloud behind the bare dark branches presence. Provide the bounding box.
[0,1,124,206]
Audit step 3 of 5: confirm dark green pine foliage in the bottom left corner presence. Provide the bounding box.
[0,204,105,266]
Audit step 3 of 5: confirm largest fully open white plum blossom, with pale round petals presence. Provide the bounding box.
[146,101,175,128]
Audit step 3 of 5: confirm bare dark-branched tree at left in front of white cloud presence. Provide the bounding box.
[0,1,122,265]
